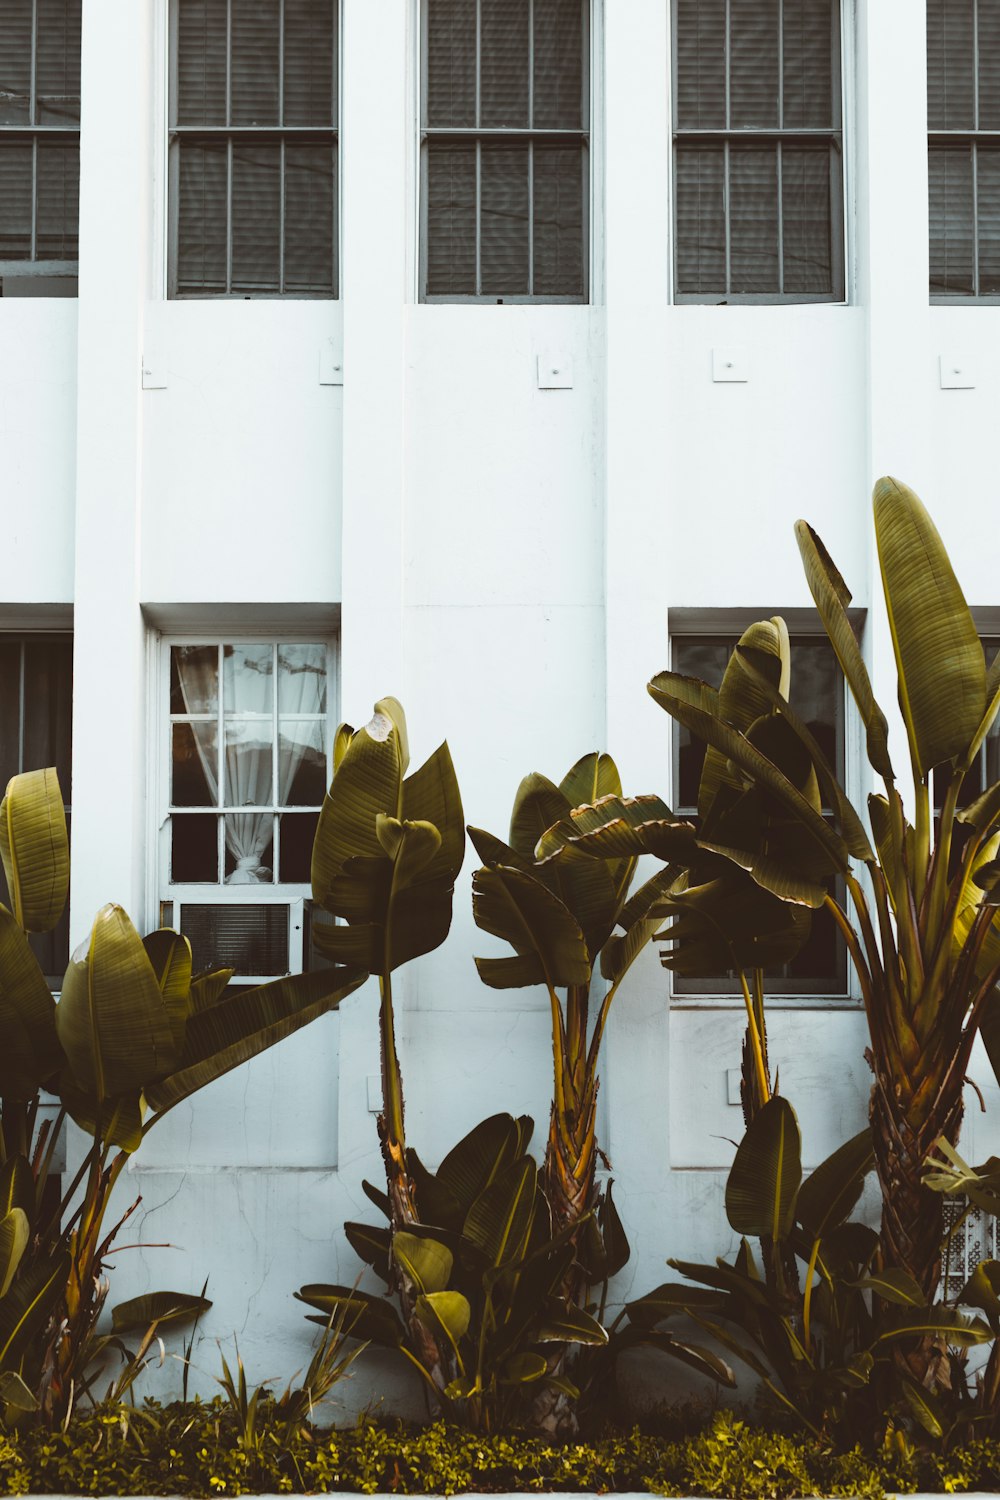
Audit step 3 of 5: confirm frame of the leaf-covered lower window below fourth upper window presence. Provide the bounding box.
[667,608,867,1010]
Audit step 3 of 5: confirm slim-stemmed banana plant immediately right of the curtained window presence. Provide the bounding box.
[312,698,465,1227]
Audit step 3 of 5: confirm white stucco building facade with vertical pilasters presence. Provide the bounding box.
[0,0,1000,1401]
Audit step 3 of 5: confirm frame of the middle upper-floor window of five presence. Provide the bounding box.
[417,0,600,308]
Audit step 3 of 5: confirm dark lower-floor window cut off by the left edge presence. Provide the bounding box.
[0,633,73,989]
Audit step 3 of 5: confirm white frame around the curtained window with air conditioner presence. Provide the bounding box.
[150,621,339,986]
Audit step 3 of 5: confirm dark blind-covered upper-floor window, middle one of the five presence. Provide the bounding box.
[421,0,591,302]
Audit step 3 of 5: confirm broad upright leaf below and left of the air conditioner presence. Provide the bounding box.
[55,905,177,1103]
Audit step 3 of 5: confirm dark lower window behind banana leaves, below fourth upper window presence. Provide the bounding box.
[672,611,847,996]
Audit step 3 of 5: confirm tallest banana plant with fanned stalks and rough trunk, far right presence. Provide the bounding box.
[649,479,1000,1385]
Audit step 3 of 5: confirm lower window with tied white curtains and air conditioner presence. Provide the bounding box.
[160,638,330,980]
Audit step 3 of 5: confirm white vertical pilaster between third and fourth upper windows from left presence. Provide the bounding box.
[595,0,672,1266]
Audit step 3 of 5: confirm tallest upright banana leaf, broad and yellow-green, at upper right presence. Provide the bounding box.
[873,477,987,776]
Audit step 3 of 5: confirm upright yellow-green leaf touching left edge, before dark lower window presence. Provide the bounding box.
[0,767,69,933]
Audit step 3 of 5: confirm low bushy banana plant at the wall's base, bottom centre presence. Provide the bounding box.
[297,1115,641,1431]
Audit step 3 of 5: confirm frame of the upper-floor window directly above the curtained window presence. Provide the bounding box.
[163,0,343,302]
